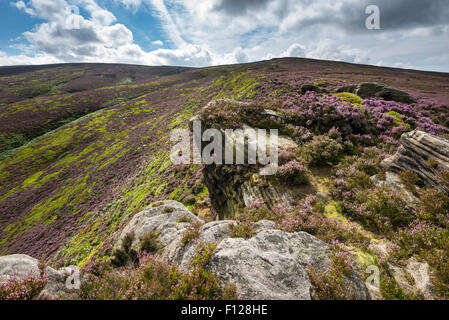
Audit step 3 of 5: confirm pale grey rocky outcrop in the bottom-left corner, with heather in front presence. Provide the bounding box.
[0,254,79,300]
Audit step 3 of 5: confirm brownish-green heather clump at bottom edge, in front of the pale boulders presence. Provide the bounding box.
[79,242,237,300]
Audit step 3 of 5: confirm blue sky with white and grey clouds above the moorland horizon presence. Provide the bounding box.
[0,0,449,72]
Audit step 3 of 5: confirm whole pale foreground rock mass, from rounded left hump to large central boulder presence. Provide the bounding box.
[116,201,369,300]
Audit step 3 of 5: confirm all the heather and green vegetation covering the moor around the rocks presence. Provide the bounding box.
[0,59,449,299]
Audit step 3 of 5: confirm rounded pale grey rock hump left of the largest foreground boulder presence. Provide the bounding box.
[114,200,203,253]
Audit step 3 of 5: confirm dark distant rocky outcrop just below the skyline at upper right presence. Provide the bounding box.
[337,82,416,103]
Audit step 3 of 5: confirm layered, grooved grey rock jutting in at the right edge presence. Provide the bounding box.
[382,131,449,194]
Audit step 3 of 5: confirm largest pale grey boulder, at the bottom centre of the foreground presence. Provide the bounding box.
[208,230,369,300]
